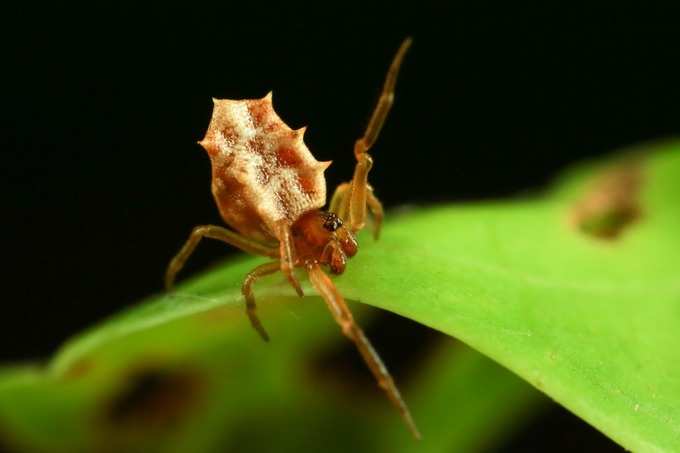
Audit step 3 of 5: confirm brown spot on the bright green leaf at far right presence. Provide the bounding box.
[573,160,642,239]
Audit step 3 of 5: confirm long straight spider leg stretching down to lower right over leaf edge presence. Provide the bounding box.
[307,263,420,439]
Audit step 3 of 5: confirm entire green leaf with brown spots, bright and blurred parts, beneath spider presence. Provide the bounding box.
[0,139,680,452]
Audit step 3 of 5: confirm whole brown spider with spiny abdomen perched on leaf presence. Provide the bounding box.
[165,38,420,438]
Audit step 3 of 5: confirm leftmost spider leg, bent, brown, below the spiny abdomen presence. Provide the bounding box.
[165,225,279,290]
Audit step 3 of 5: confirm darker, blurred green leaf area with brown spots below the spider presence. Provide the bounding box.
[0,292,541,452]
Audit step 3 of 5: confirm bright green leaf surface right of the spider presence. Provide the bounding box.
[338,143,680,451]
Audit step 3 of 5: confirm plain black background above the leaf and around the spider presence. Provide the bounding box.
[0,0,680,445]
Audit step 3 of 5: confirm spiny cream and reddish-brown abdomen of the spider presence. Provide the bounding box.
[199,93,330,244]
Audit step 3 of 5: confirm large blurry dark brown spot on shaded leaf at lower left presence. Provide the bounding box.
[104,366,204,430]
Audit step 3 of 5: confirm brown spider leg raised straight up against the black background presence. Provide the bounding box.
[349,38,411,232]
